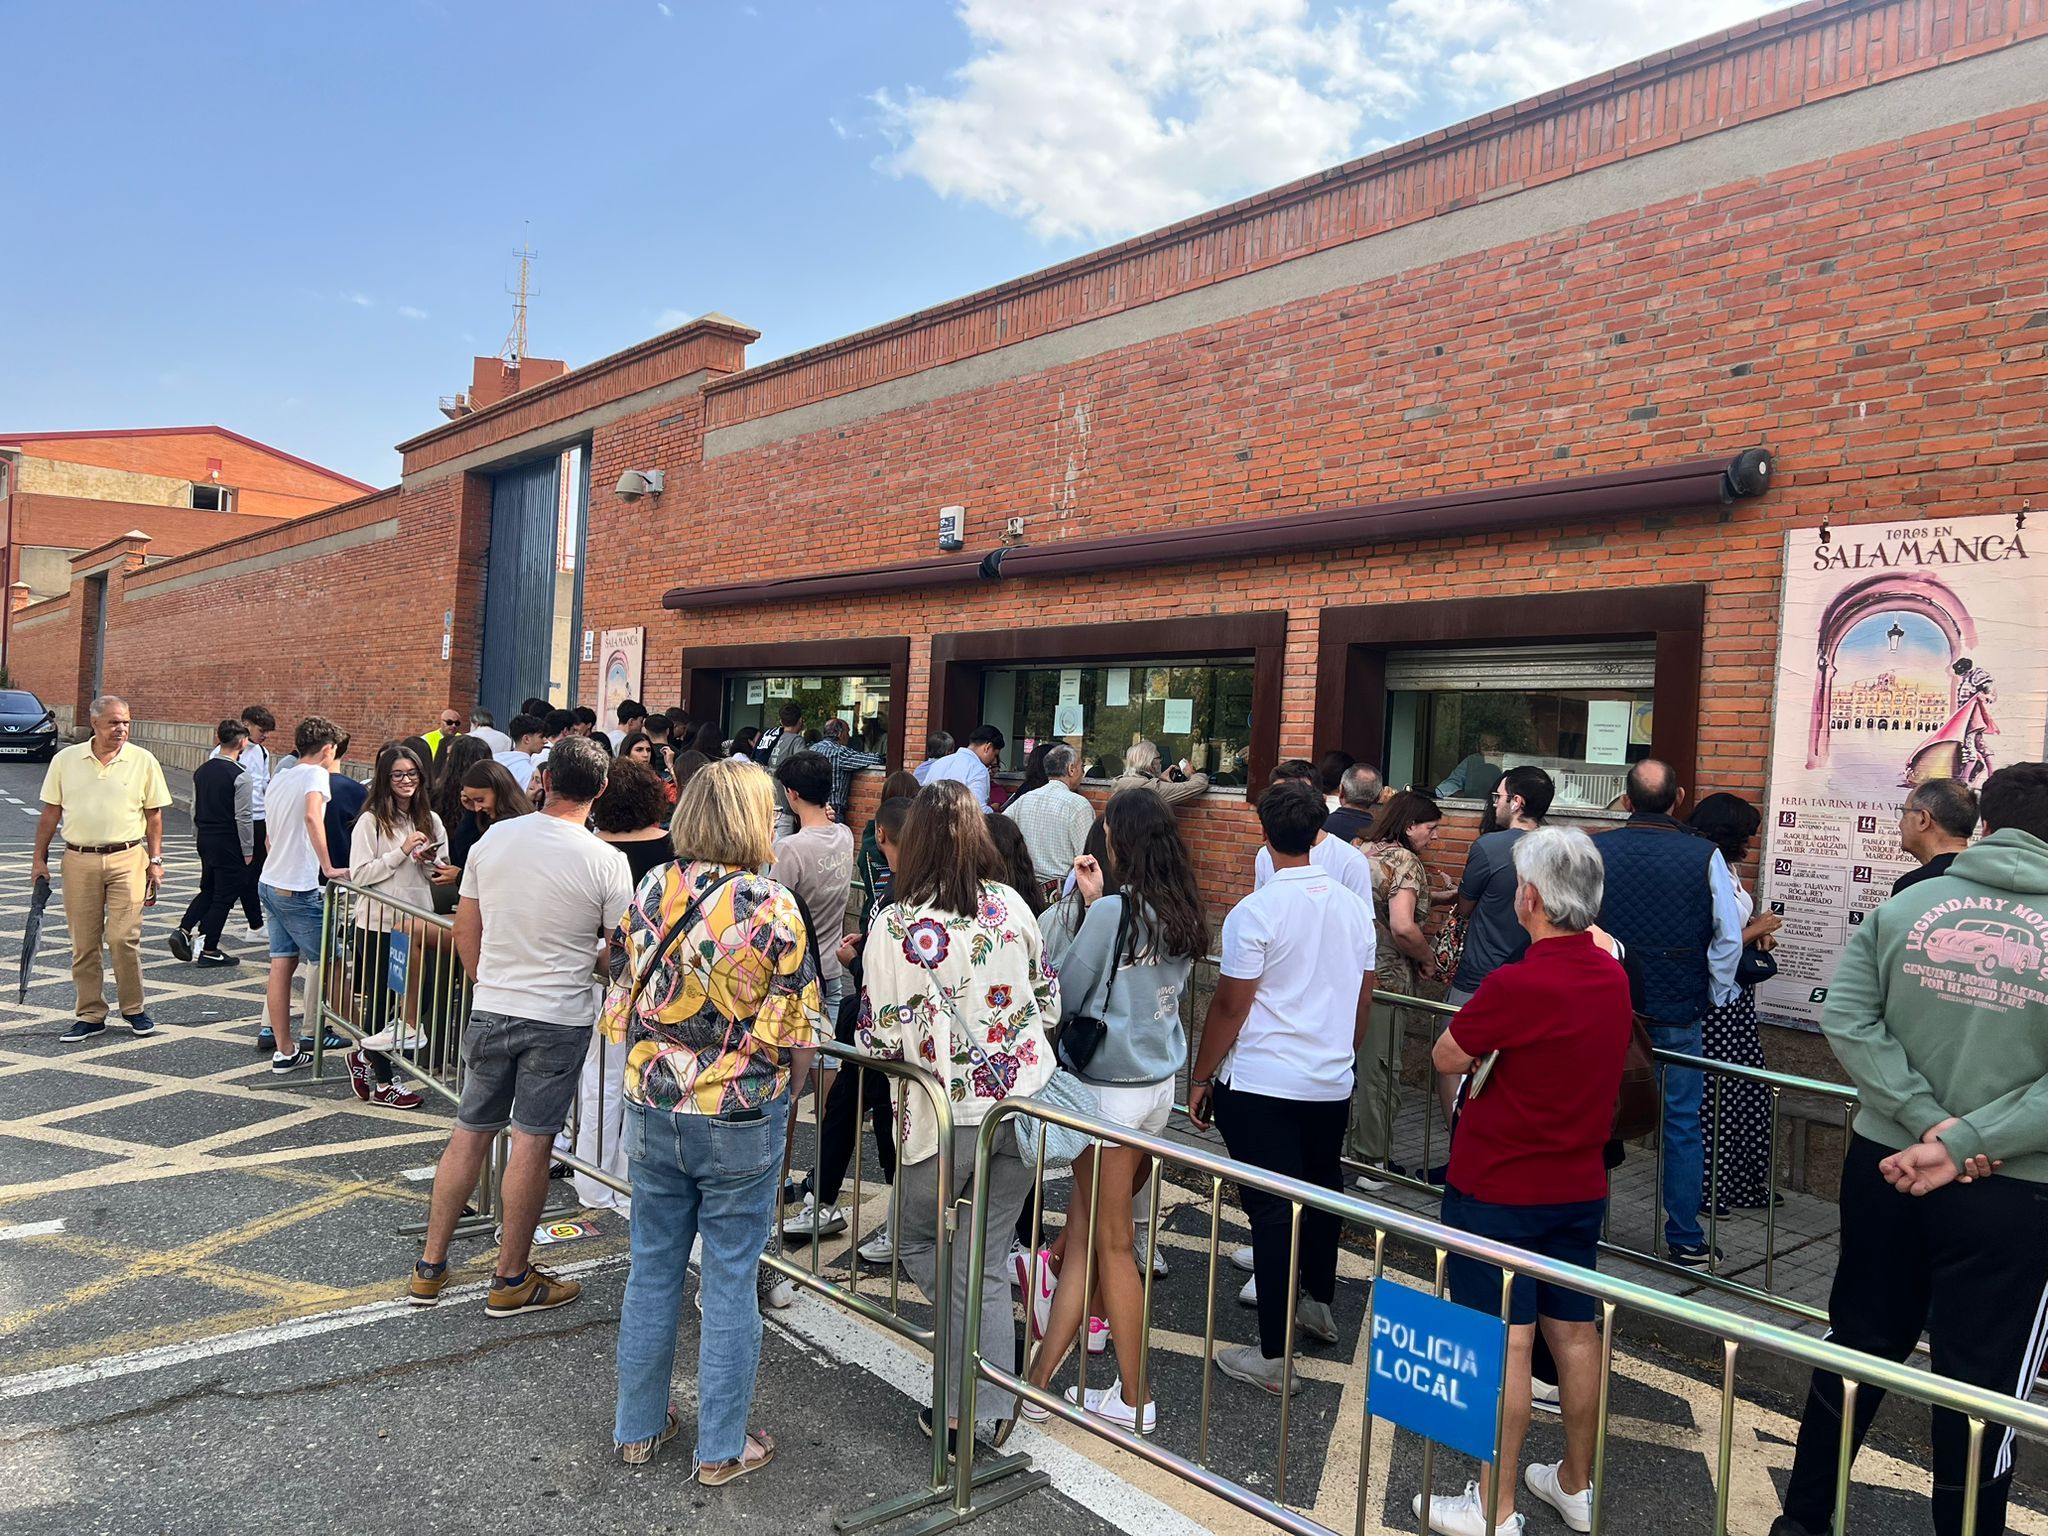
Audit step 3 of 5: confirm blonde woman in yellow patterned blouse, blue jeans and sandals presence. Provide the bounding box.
[600,760,823,1485]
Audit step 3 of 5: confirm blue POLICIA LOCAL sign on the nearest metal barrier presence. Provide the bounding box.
[1372,1278,1507,1460]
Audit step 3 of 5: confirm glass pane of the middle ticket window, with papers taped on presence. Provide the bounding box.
[981,662,1251,786]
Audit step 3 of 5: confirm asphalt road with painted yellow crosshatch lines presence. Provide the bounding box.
[0,766,2048,1536]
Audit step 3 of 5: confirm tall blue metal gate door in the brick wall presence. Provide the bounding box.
[477,455,561,723]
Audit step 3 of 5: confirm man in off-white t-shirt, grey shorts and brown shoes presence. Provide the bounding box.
[410,735,633,1317]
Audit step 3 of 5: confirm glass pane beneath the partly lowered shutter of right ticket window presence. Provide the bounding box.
[1386,684,1653,809]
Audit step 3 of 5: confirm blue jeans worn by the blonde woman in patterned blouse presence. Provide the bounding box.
[612,1098,788,1462]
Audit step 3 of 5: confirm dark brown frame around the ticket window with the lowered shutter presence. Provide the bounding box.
[1315,582,1706,807]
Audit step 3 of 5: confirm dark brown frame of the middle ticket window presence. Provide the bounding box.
[928,612,1286,801]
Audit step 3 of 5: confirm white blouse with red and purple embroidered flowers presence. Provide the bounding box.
[860,881,1059,1163]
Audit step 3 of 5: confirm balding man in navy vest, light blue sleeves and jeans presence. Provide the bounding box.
[1593,758,1743,1270]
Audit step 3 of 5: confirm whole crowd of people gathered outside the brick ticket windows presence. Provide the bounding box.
[35,698,2048,1536]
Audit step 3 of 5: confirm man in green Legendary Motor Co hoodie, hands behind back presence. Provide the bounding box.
[1772,762,2048,1536]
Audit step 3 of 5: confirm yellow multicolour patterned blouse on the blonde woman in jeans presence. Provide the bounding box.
[600,862,823,1114]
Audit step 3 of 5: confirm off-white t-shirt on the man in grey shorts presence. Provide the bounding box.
[461,813,633,1030]
